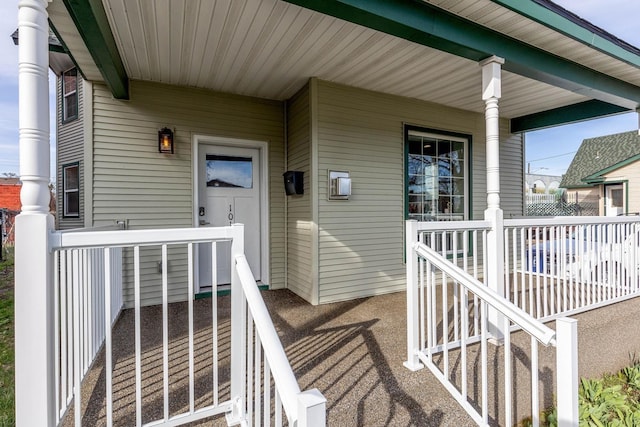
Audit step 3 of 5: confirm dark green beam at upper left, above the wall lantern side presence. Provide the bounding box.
[62,0,129,99]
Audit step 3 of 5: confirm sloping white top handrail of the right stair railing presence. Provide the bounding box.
[414,242,556,346]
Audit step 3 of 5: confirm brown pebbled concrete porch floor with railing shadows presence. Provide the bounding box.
[63,290,640,426]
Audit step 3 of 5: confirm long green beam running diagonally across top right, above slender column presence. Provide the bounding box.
[285,0,640,113]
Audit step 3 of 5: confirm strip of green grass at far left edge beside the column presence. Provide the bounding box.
[0,251,15,427]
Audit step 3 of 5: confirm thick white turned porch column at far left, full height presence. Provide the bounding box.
[15,0,55,426]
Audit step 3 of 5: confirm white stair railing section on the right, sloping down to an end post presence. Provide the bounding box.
[405,221,578,426]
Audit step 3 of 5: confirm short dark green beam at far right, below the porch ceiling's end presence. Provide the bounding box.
[511,99,634,133]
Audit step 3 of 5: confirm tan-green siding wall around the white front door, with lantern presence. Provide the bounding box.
[92,81,284,305]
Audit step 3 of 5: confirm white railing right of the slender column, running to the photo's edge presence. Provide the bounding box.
[504,217,640,320]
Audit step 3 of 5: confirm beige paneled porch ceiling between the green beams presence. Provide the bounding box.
[87,0,589,117]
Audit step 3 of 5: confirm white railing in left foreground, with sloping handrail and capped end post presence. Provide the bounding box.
[48,225,325,427]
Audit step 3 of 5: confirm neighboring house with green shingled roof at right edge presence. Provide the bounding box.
[560,131,640,216]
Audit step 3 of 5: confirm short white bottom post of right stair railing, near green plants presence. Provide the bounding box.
[556,317,578,427]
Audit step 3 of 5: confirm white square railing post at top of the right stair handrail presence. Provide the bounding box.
[404,220,424,371]
